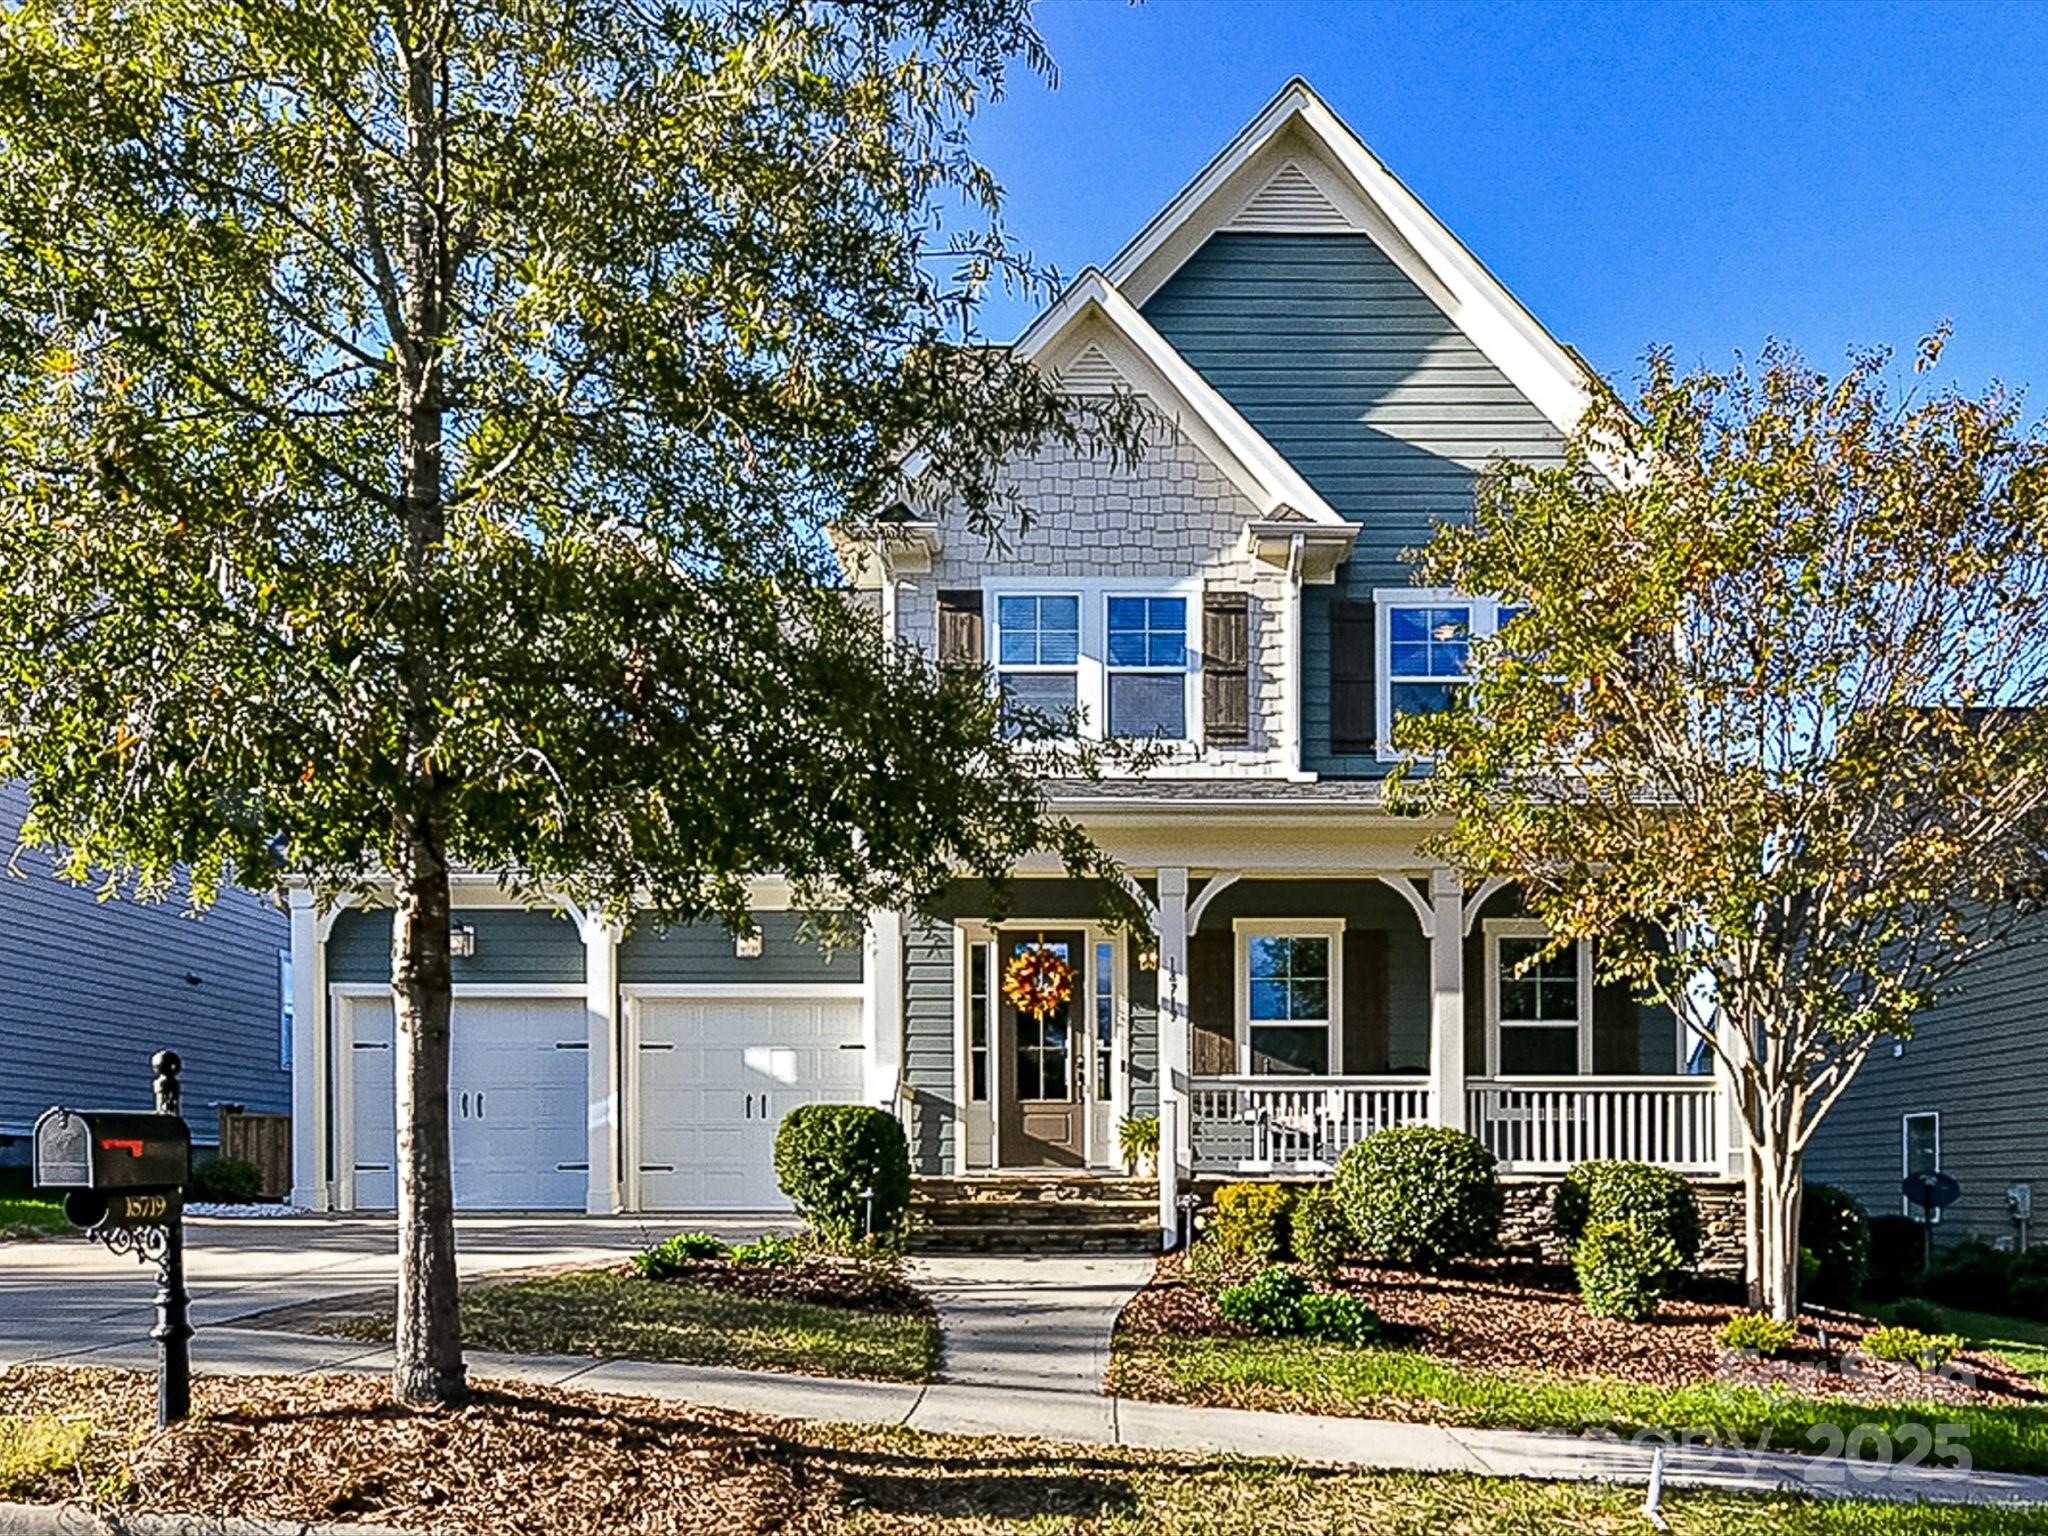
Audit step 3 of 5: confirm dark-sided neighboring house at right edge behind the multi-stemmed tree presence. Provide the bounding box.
[1806,918,2048,1247]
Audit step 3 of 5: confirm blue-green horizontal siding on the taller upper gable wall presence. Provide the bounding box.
[1145,233,1561,776]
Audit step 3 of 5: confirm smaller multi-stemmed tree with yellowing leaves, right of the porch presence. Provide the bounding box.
[1397,336,2048,1317]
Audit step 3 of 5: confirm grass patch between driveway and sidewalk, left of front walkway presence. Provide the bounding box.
[330,1270,938,1380]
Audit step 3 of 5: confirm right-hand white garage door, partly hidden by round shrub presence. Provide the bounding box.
[633,997,862,1210]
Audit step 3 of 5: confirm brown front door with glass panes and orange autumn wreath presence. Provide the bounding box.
[995,932,1090,1167]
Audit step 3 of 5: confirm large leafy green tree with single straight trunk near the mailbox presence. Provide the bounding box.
[0,0,1137,1401]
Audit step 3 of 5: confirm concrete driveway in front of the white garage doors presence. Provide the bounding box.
[0,1212,788,1366]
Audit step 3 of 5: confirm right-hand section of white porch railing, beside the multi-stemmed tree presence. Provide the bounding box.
[1464,1077,1722,1174]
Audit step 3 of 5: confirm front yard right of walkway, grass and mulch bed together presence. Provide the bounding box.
[1110,1260,2048,1473]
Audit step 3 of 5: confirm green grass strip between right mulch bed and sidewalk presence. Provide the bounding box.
[1112,1337,2048,1473]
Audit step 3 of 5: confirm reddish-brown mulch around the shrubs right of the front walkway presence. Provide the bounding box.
[1116,1253,2048,1407]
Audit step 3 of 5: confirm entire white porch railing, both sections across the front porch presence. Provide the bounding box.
[1188,1077,1722,1174]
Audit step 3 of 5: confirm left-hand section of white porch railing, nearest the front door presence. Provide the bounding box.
[1188,1077,1430,1174]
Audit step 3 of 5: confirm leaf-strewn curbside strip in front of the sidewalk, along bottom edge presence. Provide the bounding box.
[0,1368,2048,1536]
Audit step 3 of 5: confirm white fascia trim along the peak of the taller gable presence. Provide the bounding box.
[1108,76,1591,432]
